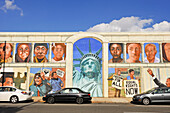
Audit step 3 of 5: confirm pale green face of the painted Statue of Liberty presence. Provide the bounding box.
[82,59,97,78]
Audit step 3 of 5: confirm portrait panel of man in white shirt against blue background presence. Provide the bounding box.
[144,43,160,63]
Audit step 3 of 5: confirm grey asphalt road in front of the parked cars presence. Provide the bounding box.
[0,102,170,113]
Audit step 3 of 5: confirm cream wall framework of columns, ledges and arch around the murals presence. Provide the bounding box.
[0,32,170,97]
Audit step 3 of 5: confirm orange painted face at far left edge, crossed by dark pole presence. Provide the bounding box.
[0,43,12,59]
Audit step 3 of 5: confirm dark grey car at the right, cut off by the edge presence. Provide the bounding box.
[132,87,170,105]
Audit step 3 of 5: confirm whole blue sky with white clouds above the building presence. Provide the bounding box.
[0,0,170,32]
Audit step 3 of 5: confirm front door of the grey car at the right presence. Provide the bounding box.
[151,88,164,102]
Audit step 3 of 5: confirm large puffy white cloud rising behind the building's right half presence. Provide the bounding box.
[87,16,170,32]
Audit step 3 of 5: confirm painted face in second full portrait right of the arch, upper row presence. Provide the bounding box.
[128,43,141,62]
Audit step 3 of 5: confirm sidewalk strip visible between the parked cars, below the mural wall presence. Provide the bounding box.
[32,97,132,103]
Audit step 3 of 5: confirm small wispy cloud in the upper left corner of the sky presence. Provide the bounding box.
[0,0,24,16]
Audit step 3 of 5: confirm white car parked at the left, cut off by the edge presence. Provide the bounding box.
[0,86,32,103]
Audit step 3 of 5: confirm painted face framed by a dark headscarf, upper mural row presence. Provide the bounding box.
[17,44,30,60]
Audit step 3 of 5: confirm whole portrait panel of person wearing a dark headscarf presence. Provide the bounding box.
[15,43,31,63]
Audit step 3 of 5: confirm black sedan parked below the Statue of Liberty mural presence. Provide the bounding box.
[43,88,91,104]
